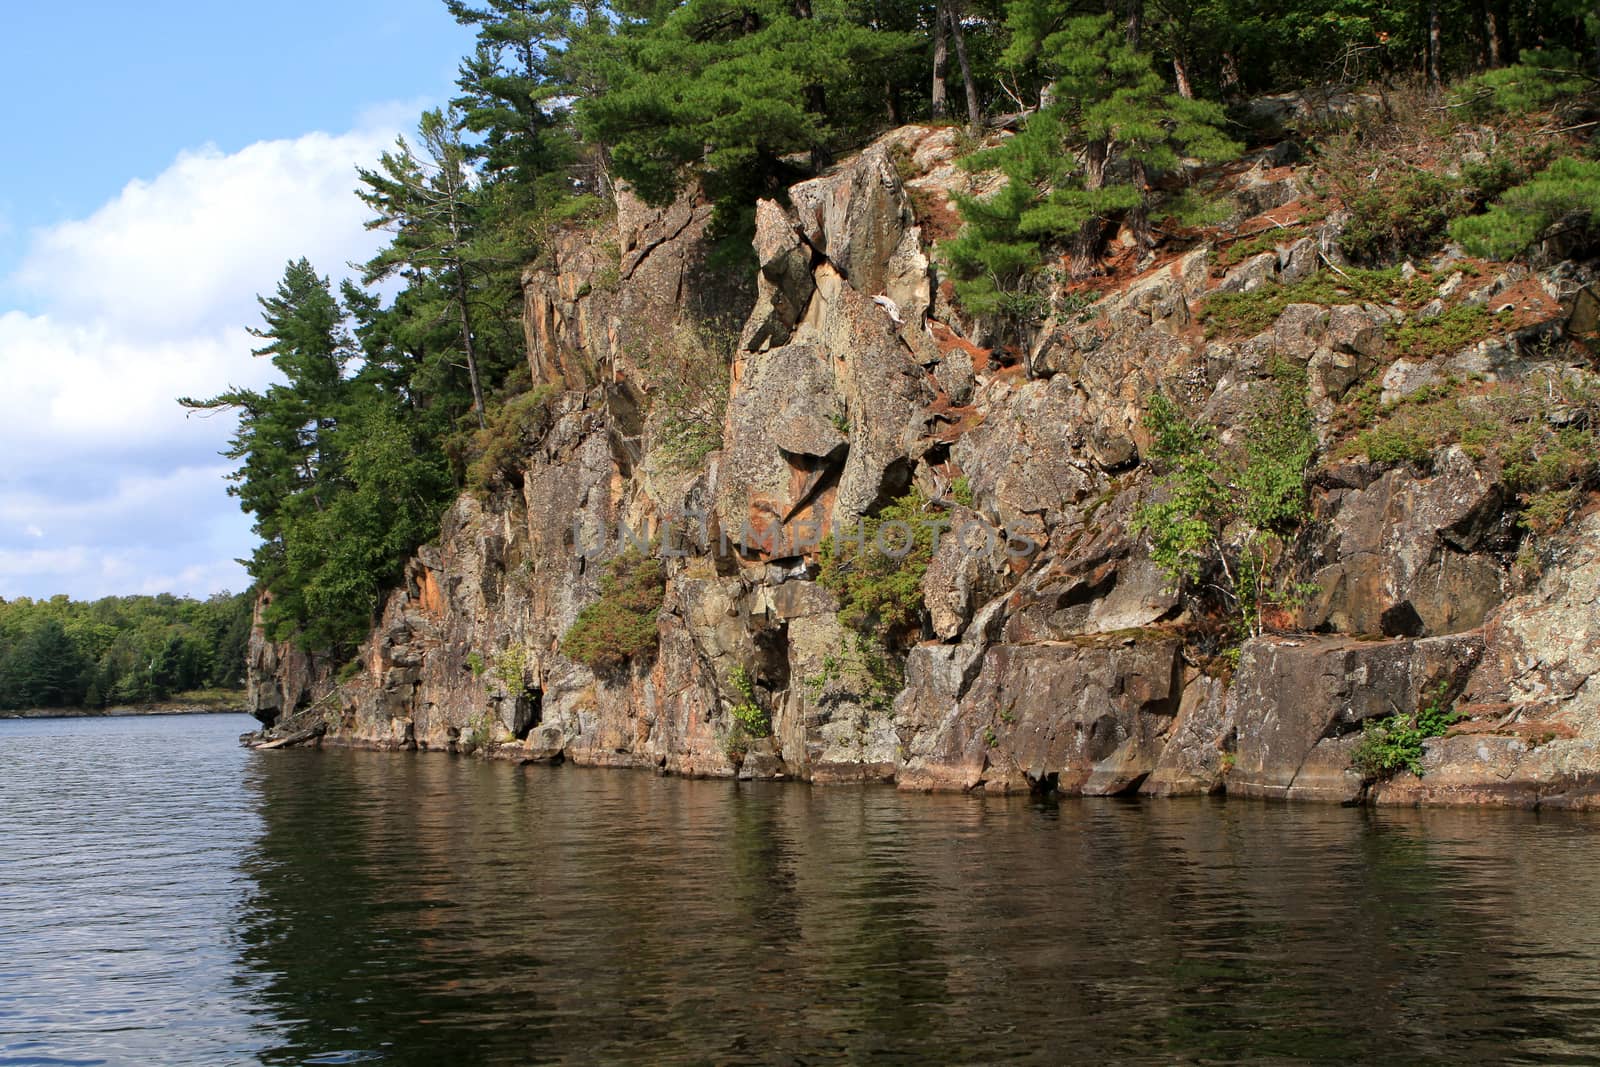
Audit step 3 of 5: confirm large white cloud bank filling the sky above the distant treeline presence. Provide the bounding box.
[0,119,414,597]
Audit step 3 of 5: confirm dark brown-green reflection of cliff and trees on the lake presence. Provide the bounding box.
[232,753,1600,1064]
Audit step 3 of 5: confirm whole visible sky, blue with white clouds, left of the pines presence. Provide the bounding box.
[0,0,472,598]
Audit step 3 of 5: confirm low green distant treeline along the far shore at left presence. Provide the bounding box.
[0,592,253,709]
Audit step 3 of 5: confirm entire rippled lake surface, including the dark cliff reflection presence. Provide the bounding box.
[0,715,1600,1065]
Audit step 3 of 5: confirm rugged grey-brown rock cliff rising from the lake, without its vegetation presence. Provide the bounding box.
[251,128,1600,808]
